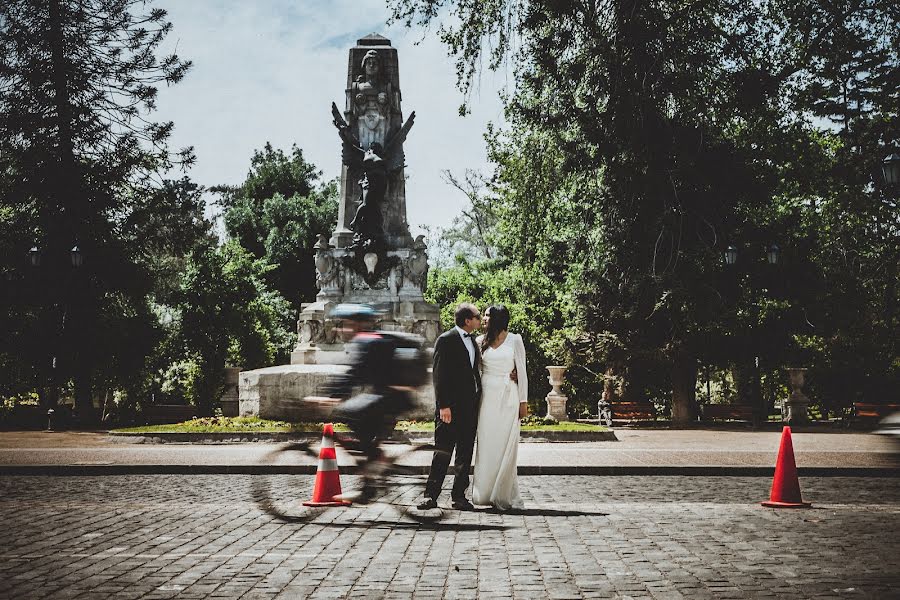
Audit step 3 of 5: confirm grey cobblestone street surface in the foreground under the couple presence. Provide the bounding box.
[0,475,900,600]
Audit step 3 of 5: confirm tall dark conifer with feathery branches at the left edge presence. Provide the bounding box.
[0,0,192,419]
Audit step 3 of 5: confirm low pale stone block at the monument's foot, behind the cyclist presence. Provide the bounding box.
[238,360,434,422]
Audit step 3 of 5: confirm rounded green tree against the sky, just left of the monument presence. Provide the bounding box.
[212,143,338,311]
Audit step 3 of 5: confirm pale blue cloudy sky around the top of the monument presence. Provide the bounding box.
[154,0,505,235]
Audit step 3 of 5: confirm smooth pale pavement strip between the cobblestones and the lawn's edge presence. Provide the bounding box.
[0,430,900,472]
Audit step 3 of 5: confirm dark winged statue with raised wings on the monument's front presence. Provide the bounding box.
[331,102,416,250]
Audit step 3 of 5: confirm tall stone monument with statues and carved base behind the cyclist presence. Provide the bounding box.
[239,34,440,420]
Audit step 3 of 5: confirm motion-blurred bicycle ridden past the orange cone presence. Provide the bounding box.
[252,399,443,523]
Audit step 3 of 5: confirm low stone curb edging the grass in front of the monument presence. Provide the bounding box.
[108,431,619,444]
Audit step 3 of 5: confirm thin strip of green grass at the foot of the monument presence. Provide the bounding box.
[112,417,606,433]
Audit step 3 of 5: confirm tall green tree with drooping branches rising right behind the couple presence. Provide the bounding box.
[398,2,768,421]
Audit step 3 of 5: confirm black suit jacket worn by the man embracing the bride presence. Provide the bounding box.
[432,328,481,419]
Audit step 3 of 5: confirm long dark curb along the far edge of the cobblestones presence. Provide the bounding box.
[0,464,900,478]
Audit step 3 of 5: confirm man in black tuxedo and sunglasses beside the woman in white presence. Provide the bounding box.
[418,302,481,510]
